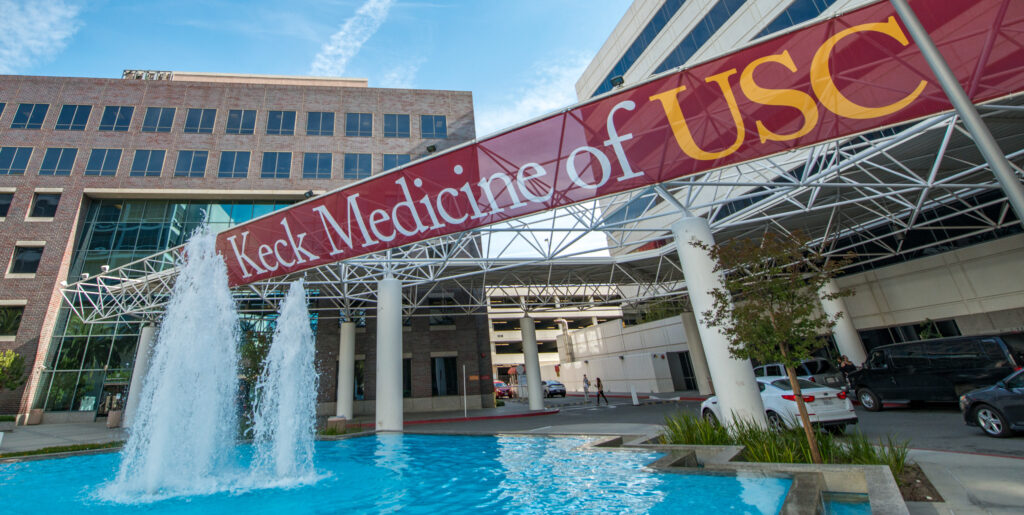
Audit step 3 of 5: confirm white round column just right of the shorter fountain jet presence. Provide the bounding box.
[376,277,402,431]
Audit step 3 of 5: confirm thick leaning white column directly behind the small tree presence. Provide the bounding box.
[672,216,767,426]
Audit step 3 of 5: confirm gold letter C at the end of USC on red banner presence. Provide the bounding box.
[811,16,928,120]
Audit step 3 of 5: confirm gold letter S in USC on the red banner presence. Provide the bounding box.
[739,50,818,143]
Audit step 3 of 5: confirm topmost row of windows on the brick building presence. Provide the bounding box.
[0,102,447,139]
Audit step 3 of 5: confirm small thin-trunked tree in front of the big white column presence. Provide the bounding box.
[692,232,851,463]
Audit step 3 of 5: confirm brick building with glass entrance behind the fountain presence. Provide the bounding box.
[0,71,489,422]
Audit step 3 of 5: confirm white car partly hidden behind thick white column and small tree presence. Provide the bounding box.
[700,376,857,434]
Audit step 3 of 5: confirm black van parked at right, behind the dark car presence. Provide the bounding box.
[850,336,1024,412]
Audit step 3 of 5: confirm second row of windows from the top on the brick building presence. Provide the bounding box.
[0,146,413,179]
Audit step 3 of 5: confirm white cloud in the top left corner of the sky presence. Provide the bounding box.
[0,0,80,74]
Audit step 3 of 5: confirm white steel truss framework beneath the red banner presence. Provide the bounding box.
[62,95,1024,321]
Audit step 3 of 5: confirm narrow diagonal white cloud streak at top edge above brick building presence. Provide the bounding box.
[309,0,394,77]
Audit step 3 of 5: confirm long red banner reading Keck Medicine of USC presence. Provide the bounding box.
[217,0,1024,286]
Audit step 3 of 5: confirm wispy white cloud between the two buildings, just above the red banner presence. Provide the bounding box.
[476,55,590,136]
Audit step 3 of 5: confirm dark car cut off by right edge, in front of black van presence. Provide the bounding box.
[961,370,1024,438]
